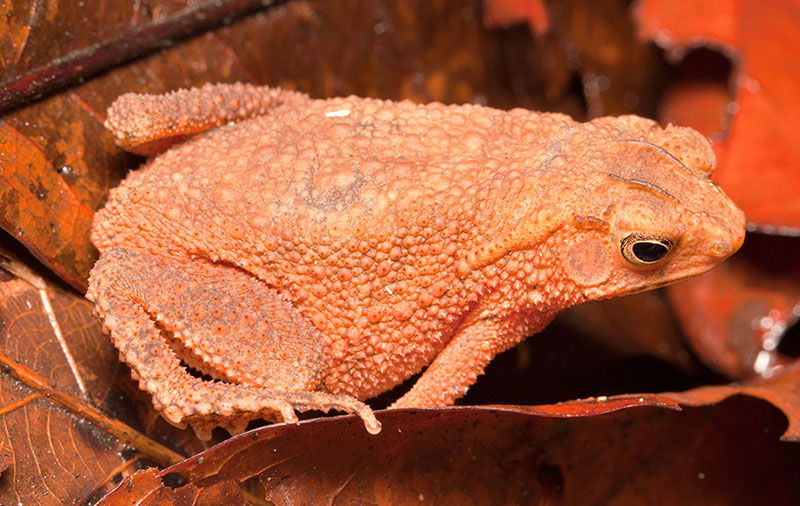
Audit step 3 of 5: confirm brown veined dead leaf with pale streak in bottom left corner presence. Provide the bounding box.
[0,253,203,504]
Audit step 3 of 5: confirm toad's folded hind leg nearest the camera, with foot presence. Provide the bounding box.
[87,248,380,437]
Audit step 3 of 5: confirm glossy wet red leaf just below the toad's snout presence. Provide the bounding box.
[668,234,800,380]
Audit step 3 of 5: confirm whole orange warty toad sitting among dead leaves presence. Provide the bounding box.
[88,85,744,434]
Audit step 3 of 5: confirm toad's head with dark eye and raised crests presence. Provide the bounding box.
[559,116,745,300]
